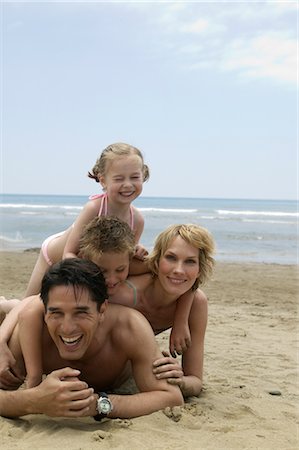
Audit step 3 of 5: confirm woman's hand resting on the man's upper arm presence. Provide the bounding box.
[153,351,184,389]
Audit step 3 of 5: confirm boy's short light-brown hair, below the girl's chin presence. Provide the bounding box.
[78,216,135,260]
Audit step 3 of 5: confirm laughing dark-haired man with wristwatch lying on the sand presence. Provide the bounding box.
[0,258,183,420]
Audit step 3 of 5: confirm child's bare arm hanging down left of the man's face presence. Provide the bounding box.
[18,300,45,389]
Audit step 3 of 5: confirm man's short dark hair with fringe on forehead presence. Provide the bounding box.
[40,258,108,310]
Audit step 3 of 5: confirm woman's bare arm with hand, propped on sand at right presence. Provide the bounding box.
[153,289,208,397]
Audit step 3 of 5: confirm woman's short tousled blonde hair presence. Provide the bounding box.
[146,224,215,291]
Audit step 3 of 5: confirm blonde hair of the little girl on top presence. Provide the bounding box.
[88,142,149,183]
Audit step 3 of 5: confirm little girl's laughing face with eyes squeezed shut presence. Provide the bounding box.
[100,155,143,203]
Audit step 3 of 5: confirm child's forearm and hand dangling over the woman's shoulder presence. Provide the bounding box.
[169,290,194,358]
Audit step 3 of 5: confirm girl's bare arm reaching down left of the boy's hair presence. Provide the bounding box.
[62,199,102,259]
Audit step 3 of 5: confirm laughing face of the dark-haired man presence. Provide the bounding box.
[45,286,106,360]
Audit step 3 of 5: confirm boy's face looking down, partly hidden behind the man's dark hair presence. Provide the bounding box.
[92,252,130,297]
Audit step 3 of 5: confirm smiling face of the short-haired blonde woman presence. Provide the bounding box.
[158,236,199,297]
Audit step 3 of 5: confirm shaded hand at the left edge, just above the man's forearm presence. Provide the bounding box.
[0,342,25,390]
